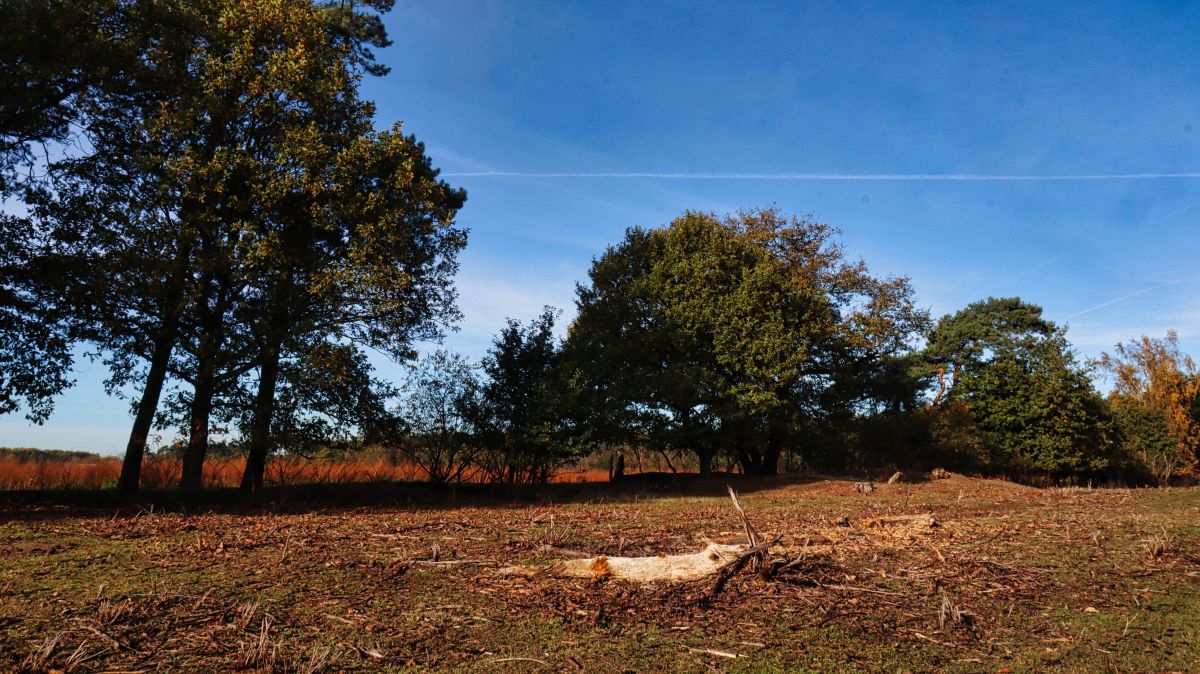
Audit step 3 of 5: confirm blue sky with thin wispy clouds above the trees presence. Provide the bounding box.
[0,0,1200,452]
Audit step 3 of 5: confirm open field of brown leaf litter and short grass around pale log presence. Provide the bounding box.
[0,476,1200,672]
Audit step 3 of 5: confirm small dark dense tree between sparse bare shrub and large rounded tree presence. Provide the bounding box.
[472,307,571,482]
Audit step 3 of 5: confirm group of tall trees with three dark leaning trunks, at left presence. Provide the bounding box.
[0,0,466,488]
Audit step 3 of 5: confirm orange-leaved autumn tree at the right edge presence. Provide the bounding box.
[1099,330,1200,477]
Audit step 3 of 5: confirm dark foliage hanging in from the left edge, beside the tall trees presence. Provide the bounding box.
[0,0,148,422]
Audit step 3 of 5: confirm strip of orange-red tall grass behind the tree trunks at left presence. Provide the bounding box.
[0,457,608,491]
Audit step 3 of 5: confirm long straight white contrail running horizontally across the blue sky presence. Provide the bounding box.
[442,170,1200,182]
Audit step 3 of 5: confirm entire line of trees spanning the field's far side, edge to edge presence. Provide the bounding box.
[0,0,1200,494]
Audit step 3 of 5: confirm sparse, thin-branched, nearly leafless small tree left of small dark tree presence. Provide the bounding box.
[400,350,480,485]
